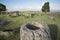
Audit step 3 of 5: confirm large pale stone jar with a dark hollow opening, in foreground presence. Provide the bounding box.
[20,22,51,40]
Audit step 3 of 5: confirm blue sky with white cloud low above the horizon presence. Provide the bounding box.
[0,0,60,11]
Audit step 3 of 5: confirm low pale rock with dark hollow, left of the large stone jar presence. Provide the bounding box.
[0,28,19,37]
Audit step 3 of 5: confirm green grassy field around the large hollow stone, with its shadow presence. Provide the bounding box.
[0,13,60,40]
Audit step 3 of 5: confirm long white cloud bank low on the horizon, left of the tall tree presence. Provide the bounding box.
[8,6,41,11]
